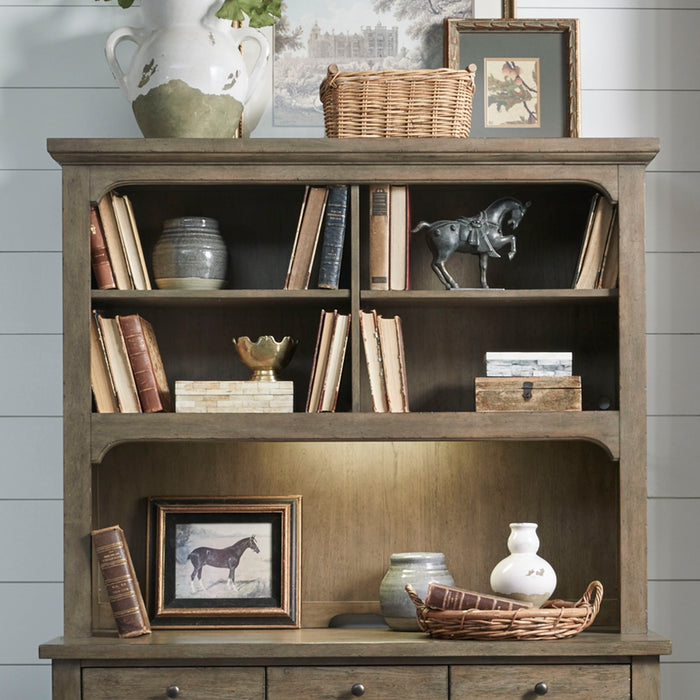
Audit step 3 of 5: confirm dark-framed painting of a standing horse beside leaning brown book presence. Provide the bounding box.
[147,496,301,629]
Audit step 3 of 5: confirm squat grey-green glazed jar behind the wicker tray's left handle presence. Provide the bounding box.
[379,552,454,632]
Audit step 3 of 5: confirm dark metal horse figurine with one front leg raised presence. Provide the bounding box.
[411,197,531,289]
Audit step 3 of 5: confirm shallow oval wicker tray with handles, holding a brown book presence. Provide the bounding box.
[406,581,603,641]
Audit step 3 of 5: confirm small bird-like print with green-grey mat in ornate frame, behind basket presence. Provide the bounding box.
[444,19,580,138]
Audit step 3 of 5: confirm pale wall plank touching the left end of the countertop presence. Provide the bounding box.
[0,583,63,664]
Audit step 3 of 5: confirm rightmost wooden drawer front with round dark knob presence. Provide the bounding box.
[450,664,630,700]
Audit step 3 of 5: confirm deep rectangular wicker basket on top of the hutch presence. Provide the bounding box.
[320,65,476,138]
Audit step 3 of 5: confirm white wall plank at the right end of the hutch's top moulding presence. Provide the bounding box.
[581,90,700,172]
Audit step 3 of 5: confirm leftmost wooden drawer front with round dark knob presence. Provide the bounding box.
[82,666,265,700]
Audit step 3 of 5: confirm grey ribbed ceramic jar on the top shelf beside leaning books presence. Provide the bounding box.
[153,216,228,289]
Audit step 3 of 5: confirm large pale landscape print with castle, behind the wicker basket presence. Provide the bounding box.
[252,0,512,137]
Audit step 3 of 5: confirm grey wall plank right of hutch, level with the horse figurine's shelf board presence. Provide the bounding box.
[646,253,700,334]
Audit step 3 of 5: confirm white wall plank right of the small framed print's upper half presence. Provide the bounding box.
[518,7,700,90]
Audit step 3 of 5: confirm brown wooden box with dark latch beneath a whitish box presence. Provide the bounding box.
[474,376,581,412]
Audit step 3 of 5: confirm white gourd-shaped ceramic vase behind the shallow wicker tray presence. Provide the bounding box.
[491,523,557,607]
